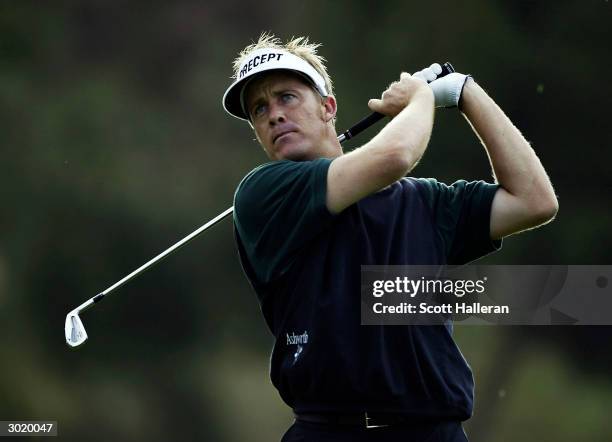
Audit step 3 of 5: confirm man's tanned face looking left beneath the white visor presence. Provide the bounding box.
[245,71,336,161]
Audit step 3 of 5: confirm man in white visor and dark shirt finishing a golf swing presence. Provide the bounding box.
[223,34,557,442]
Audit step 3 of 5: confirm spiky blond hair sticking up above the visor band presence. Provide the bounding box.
[233,32,334,95]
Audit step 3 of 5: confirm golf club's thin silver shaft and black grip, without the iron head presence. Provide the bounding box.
[77,62,455,313]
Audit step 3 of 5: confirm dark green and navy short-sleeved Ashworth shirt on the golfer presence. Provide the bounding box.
[234,158,501,420]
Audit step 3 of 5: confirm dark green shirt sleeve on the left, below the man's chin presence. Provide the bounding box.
[234,158,333,283]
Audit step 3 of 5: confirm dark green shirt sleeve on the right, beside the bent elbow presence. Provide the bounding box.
[419,178,502,265]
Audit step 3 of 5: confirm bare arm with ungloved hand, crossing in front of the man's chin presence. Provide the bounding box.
[326,73,434,213]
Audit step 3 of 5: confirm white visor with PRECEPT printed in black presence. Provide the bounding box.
[223,48,328,121]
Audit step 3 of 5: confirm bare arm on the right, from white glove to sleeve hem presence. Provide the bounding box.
[460,78,558,239]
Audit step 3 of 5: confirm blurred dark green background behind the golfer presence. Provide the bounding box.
[0,0,612,442]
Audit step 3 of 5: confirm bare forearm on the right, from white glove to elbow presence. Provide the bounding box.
[460,79,557,211]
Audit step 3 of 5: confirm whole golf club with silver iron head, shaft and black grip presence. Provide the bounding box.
[64,62,455,348]
